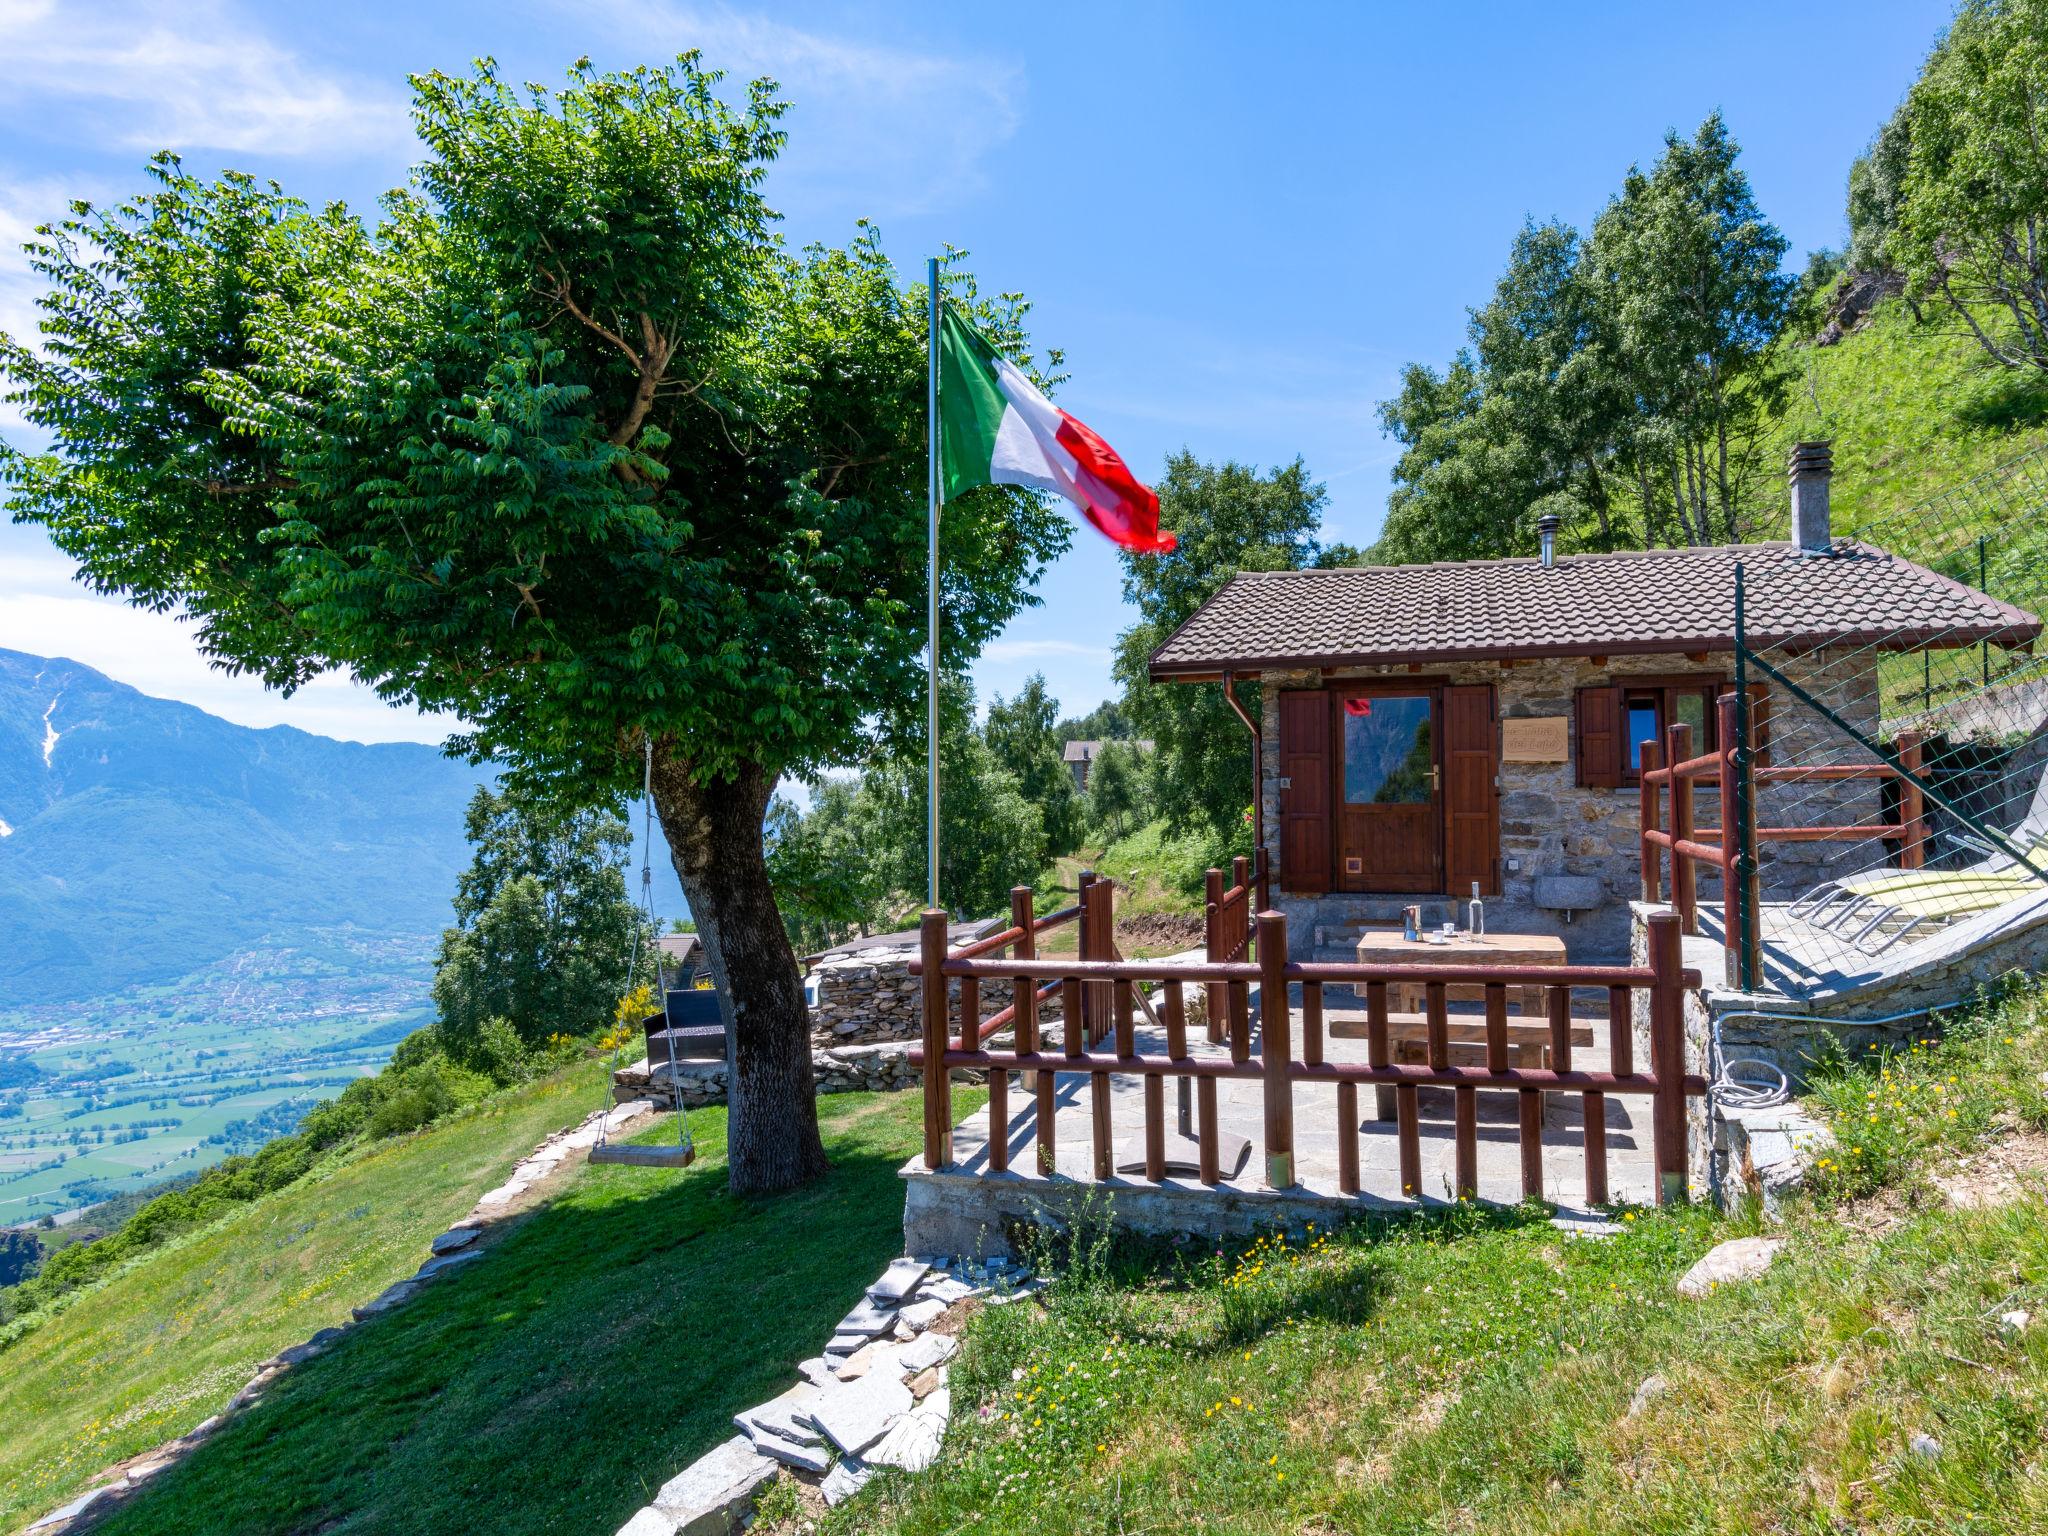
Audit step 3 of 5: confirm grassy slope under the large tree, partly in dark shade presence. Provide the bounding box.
[0,1063,937,1536]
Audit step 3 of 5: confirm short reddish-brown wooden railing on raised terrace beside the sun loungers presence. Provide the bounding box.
[1640,694,1927,950]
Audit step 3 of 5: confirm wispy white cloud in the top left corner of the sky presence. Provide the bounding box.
[0,0,412,156]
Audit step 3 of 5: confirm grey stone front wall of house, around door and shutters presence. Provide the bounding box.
[1260,651,1878,963]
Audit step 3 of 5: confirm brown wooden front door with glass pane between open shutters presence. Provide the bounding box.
[1331,684,1444,895]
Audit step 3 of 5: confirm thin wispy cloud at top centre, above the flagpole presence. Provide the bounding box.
[563,0,1024,215]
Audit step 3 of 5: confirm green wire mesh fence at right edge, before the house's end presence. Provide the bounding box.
[1733,438,2048,991]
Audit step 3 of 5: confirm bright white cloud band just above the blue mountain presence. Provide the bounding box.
[0,524,457,743]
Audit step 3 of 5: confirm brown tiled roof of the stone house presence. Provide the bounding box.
[1151,541,2042,678]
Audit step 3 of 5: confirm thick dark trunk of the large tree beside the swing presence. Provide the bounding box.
[653,743,825,1194]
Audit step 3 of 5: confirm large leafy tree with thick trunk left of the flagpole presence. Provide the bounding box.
[0,55,1067,1190]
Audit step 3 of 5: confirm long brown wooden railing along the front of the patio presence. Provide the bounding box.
[911,884,1706,1204]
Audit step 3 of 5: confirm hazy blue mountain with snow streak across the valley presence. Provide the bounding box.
[0,651,483,1006]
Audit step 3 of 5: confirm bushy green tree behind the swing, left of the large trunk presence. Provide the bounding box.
[434,784,653,1075]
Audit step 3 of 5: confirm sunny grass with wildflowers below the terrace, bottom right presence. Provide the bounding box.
[815,997,2048,1536]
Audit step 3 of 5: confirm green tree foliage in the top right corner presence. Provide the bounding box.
[1884,0,2048,369]
